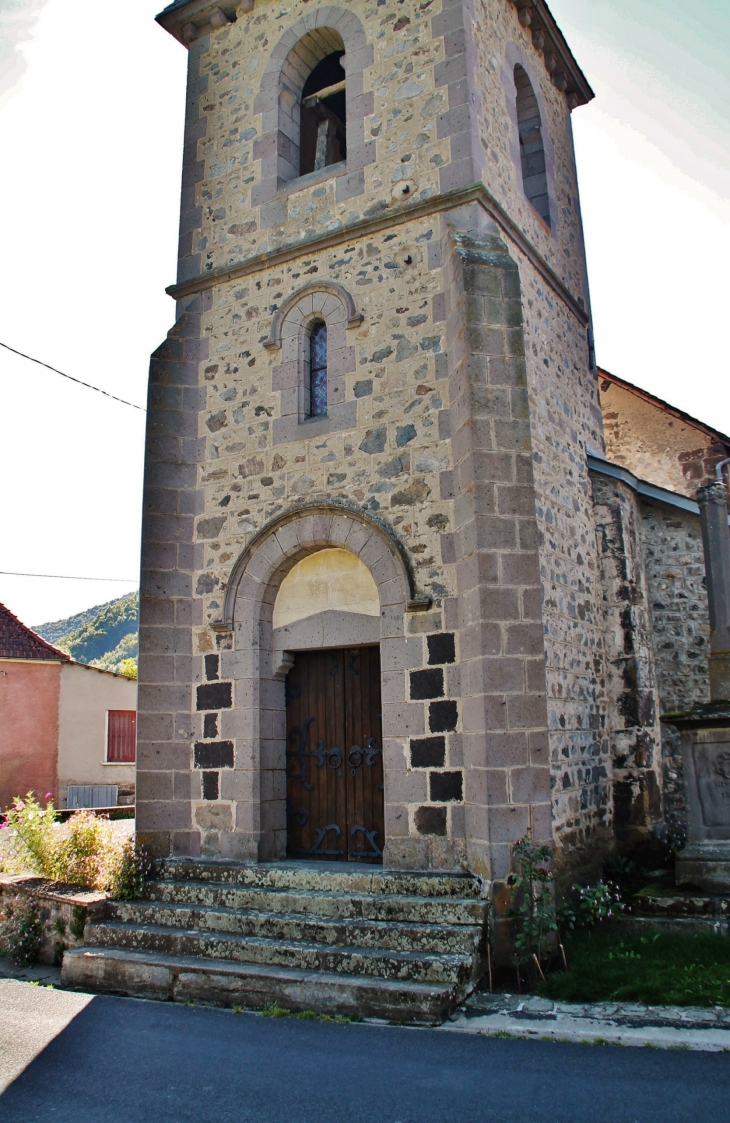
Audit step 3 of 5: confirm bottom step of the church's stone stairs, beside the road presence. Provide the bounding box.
[63,948,462,1025]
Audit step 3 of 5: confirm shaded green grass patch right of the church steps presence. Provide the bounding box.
[538,929,730,1006]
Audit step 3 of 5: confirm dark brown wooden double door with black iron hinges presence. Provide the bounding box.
[286,648,384,862]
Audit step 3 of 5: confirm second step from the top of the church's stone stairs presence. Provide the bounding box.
[146,880,484,926]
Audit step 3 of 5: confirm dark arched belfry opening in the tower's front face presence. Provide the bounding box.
[299,51,347,175]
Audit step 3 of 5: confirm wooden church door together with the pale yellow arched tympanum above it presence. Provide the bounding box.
[273,549,384,862]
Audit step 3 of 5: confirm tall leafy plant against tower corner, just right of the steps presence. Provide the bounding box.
[509,834,557,964]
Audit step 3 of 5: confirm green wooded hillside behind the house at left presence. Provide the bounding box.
[33,593,139,670]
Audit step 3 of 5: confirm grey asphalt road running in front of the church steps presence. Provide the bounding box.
[0,983,730,1123]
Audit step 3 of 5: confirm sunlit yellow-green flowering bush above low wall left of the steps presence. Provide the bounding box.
[2,793,152,900]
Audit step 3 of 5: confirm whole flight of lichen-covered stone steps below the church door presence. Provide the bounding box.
[63,860,489,1024]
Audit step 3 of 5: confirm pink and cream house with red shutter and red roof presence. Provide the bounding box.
[0,604,137,810]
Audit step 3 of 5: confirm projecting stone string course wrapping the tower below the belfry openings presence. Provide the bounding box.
[165,183,588,327]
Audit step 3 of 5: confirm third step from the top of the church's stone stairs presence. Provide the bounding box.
[108,902,482,956]
